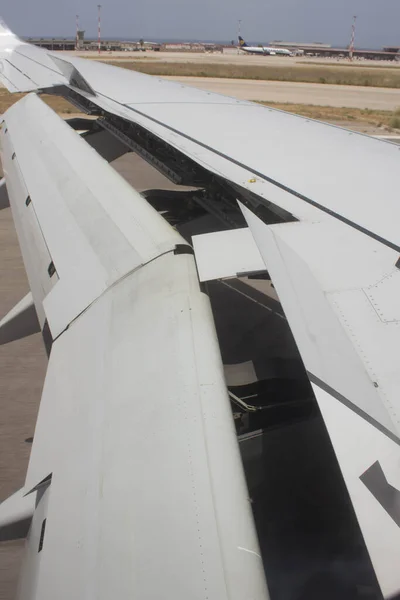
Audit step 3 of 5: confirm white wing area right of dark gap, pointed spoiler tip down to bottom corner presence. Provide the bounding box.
[241,206,400,597]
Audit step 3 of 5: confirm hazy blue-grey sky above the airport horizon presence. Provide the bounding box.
[2,0,400,47]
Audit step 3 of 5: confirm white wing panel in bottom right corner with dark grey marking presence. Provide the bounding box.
[313,384,400,598]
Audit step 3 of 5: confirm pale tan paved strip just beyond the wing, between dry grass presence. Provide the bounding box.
[164,77,400,111]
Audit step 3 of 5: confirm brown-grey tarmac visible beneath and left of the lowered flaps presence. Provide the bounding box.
[0,208,47,600]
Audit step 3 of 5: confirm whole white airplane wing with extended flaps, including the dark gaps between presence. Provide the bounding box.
[0,18,400,600]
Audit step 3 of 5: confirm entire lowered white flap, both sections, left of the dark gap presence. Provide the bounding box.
[0,95,267,600]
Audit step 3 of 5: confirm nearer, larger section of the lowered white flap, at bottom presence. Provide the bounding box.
[26,253,267,600]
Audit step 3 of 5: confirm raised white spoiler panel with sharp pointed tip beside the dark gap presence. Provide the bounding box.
[242,207,400,436]
